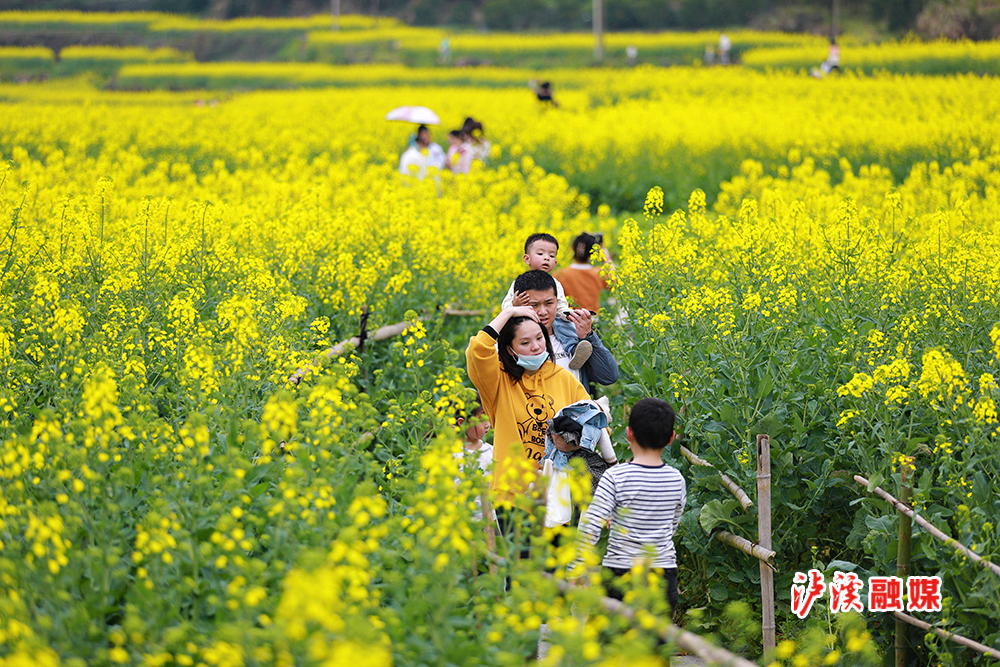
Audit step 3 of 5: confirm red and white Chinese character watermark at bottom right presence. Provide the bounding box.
[792,570,941,619]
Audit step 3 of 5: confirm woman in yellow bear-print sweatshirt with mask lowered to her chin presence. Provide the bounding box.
[465,306,590,505]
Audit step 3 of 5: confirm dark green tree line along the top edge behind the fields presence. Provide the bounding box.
[0,0,1000,39]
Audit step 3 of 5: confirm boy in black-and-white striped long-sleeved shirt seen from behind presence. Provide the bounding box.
[579,398,687,611]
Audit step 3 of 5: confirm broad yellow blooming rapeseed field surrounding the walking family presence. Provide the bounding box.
[0,28,1000,667]
